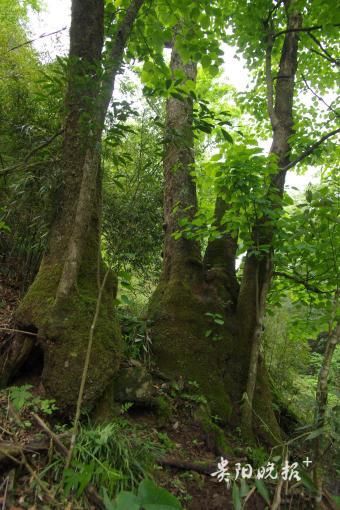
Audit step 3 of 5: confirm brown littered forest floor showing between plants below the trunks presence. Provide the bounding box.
[0,280,335,510]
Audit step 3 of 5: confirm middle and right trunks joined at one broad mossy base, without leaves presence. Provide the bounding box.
[150,0,301,443]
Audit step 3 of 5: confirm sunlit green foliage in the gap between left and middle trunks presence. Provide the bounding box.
[102,100,163,280]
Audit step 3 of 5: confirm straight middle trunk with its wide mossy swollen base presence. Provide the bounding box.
[149,41,236,420]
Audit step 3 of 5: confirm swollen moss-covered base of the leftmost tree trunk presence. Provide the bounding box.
[17,263,121,409]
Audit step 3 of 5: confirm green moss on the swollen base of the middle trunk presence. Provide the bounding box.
[149,280,231,422]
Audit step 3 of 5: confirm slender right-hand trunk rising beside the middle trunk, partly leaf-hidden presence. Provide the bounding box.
[238,0,302,435]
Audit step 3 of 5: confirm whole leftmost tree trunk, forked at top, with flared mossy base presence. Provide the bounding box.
[2,0,143,409]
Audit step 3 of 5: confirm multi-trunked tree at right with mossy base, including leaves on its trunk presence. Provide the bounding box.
[150,1,339,442]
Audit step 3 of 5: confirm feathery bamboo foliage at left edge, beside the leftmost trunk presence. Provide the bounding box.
[0,1,64,287]
